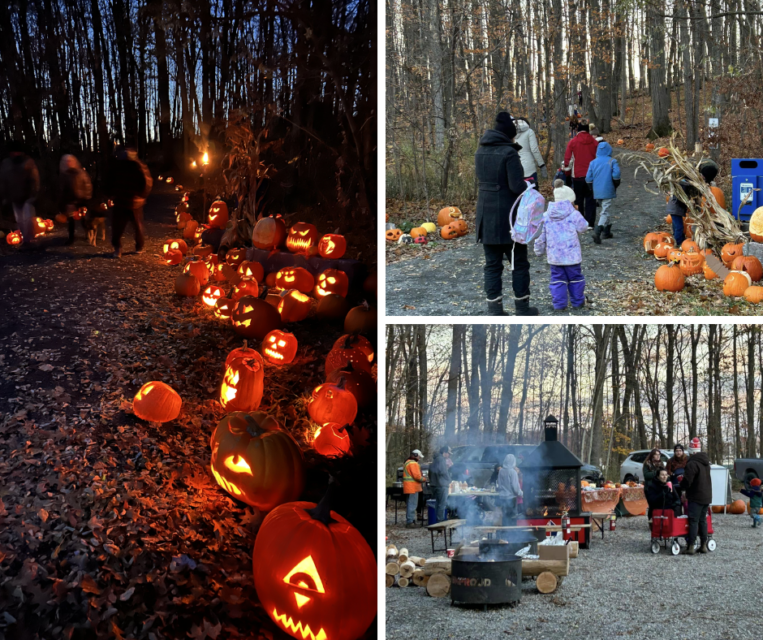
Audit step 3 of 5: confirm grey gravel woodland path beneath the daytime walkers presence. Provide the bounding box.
[387,151,665,316]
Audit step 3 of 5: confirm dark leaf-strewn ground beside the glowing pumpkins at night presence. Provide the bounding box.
[0,180,377,639]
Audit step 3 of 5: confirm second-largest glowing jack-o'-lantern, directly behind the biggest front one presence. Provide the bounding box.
[210,411,305,511]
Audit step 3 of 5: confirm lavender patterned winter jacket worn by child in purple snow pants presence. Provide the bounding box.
[535,200,588,267]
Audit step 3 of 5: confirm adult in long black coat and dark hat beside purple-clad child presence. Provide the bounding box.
[474,111,538,316]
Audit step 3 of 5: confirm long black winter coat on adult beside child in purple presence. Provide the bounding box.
[474,129,526,244]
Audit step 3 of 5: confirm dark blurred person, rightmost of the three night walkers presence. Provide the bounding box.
[106,142,153,258]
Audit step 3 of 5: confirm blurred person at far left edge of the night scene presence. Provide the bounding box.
[0,142,40,248]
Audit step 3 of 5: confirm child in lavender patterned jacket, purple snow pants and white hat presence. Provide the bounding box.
[535,181,588,311]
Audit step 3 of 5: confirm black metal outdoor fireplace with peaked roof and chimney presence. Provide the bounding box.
[519,427,583,518]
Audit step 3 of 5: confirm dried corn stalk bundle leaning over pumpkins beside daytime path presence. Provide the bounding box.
[624,134,746,251]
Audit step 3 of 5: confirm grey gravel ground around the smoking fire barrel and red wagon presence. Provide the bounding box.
[385,500,763,640]
